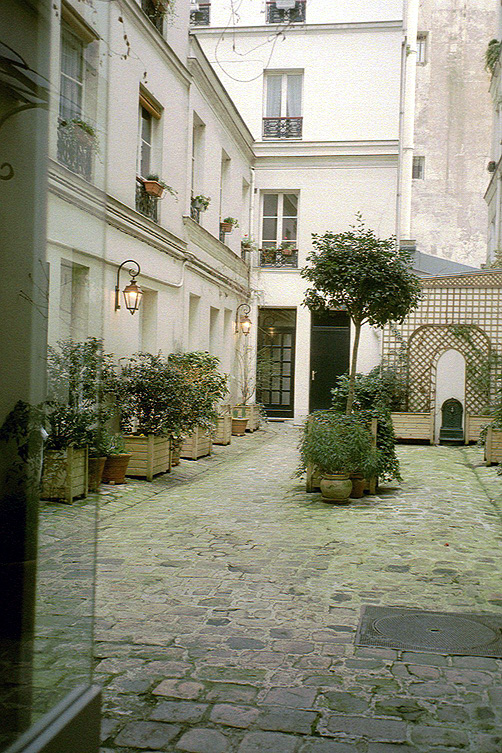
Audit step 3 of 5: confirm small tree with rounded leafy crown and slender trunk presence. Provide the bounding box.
[301,214,421,415]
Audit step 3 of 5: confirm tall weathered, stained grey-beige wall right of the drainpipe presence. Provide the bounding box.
[411,0,494,266]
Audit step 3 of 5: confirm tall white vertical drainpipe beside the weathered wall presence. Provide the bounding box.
[399,0,419,240]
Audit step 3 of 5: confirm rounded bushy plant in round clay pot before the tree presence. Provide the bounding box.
[298,411,378,504]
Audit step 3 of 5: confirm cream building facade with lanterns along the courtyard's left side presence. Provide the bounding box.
[47,0,253,400]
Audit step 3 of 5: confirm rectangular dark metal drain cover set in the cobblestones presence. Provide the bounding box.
[355,605,502,658]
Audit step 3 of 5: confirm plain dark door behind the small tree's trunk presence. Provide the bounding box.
[310,311,350,411]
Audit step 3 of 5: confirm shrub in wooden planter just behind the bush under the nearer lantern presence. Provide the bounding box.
[168,351,228,460]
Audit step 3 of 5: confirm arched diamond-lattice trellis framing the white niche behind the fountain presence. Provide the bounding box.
[408,324,491,413]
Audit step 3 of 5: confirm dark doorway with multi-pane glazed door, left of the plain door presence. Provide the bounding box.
[256,309,296,418]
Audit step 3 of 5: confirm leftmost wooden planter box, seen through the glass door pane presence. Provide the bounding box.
[40,447,88,503]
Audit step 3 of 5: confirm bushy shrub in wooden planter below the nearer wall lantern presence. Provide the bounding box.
[116,353,187,481]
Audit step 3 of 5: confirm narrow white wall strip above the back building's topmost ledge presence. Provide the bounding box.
[211,0,403,27]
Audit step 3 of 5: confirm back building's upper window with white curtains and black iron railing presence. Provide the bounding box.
[263,73,303,139]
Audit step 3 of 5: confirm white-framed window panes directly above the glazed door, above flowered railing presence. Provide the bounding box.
[261,193,298,249]
